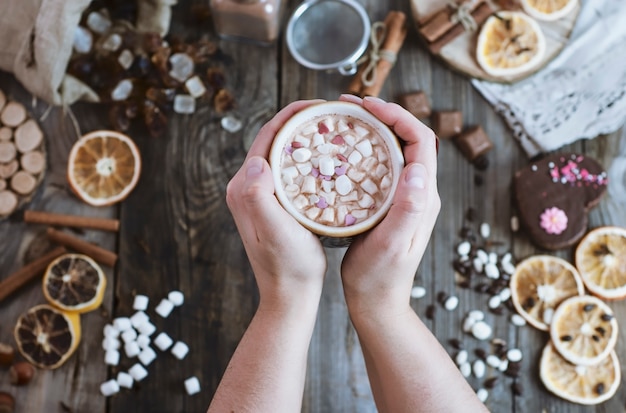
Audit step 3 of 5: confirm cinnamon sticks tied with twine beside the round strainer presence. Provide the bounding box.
[348,11,407,97]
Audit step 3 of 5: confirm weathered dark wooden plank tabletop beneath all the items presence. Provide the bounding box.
[0,0,626,413]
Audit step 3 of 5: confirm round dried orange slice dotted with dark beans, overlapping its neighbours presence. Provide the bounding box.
[550,295,618,366]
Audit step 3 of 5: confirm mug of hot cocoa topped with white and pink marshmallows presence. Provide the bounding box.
[269,101,404,246]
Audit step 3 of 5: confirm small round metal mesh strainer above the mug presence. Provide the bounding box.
[286,0,371,75]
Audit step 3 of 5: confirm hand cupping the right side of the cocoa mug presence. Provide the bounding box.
[341,95,441,316]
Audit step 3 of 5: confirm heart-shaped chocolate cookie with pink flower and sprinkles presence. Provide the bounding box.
[514,153,608,250]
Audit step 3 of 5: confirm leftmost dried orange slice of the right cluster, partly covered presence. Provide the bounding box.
[510,255,585,331]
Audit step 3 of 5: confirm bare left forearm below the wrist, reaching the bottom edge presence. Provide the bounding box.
[208,303,317,413]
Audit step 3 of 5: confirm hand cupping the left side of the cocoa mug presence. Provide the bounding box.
[226,100,326,310]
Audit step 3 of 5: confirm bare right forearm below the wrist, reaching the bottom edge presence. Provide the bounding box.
[352,307,487,413]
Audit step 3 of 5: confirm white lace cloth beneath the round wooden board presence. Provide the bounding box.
[472,0,626,157]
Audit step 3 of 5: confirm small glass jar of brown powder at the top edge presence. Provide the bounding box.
[210,0,282,44]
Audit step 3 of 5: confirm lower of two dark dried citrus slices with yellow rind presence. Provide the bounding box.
[13,304,80,369]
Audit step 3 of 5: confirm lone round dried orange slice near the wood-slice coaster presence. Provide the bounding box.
[67,130,141,206]
